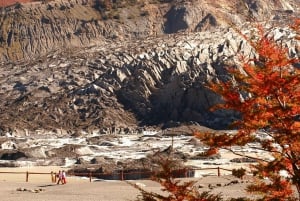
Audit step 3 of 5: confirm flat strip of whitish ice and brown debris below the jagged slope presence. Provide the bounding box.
[0,124,265,171]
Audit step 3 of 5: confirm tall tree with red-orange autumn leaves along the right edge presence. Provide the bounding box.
[196,19,300,200]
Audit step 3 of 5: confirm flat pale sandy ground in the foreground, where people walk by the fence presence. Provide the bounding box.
[0,167,258,201]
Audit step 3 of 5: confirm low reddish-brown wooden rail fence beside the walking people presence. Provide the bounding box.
[0,167,240,183]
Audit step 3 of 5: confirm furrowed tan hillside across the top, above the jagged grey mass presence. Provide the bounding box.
[0,0,300,61]
